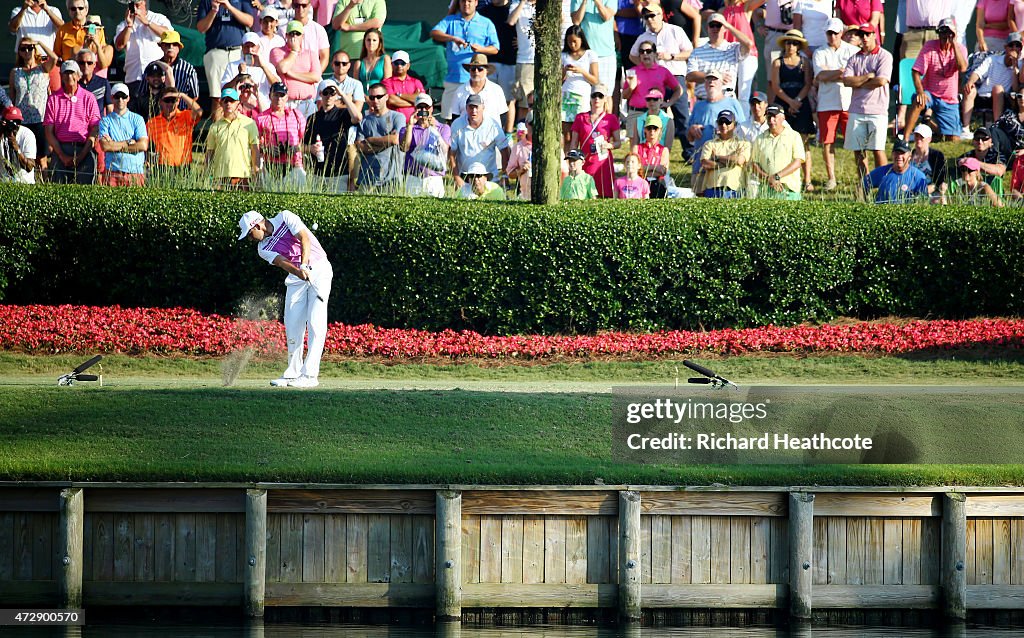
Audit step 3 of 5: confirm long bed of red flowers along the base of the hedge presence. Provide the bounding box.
[0,305,1024,359]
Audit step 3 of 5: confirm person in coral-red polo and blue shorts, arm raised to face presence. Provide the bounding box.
[903,17,967,139]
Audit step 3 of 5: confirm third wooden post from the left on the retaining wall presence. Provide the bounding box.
[434,490,462,622]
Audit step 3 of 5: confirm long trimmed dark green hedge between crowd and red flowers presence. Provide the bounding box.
[0,185,1024,333]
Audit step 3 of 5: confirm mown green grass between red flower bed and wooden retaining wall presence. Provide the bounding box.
[0,353,1024,485]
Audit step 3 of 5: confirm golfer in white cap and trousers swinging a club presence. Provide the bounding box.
[239,211,334,388]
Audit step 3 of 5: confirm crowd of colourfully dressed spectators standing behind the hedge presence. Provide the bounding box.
[0,0,1024,206]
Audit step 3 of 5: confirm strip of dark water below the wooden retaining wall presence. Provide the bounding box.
[0,619,1024,638]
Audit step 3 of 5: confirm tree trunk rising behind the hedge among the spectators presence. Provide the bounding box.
[530,0,562,204]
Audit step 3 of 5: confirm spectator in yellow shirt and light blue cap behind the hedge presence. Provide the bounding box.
[206,88,261,190]
